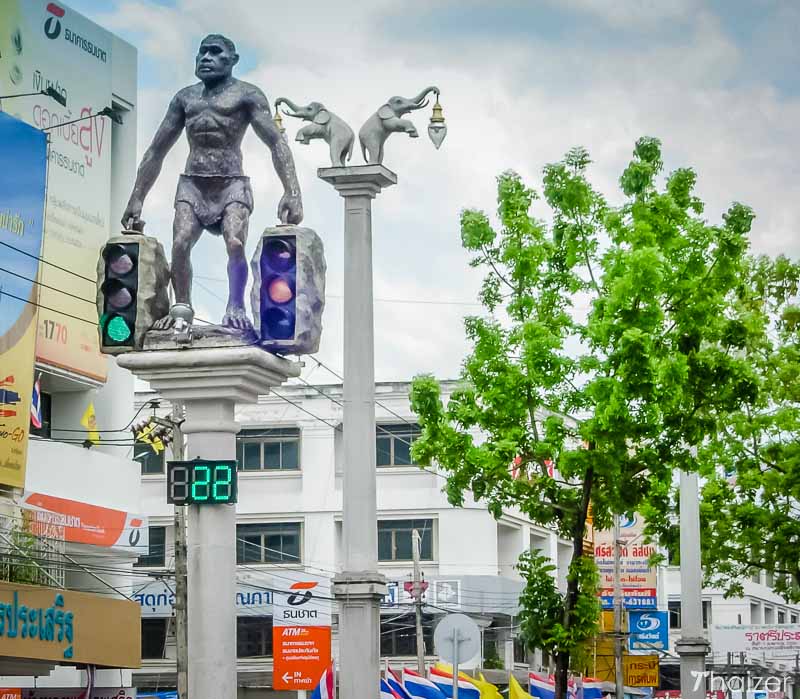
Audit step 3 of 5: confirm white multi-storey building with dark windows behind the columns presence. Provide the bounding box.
[134,383,571,696]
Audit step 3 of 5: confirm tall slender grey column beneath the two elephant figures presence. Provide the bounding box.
[317,165,397,699]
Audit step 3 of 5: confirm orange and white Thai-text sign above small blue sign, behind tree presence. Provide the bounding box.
[594,513,657,609]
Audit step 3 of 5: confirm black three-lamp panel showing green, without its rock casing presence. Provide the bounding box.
[100,241,139,349]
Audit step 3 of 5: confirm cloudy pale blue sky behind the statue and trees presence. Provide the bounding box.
[69,0,800,383]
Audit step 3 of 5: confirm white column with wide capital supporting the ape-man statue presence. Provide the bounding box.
[117,347,300,699]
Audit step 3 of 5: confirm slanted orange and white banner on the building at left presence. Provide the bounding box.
[19,491,150,555]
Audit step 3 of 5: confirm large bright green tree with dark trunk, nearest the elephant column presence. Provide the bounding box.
[411,138,757,697]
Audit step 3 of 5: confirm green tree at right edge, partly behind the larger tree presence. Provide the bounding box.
[651,257,800,602]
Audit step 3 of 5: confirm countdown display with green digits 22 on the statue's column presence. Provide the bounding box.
[167,459,237,505]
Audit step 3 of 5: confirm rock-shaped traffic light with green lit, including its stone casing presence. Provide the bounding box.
[97,235,169,354]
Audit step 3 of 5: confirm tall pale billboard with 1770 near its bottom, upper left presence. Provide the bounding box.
[0,0,112,381]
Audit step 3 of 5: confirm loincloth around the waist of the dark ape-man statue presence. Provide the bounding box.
[175,175,253,235]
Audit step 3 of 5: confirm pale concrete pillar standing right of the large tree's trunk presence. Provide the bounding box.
[675,468,709,699]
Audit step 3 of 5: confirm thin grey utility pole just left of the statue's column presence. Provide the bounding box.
[170,403,189,699]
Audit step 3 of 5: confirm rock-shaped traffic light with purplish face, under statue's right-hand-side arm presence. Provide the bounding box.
[251,225,325,354]
